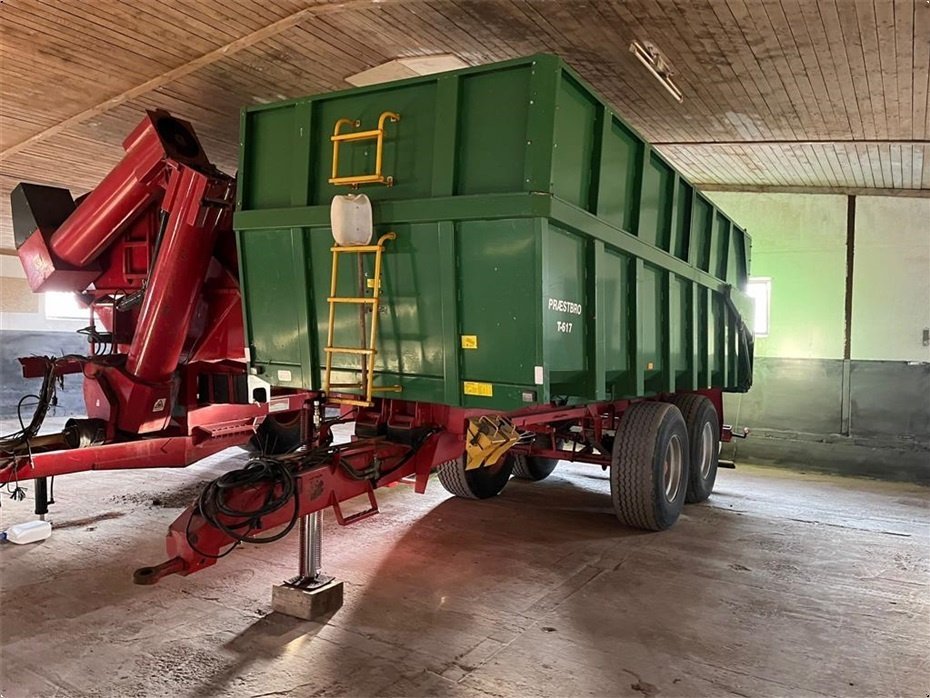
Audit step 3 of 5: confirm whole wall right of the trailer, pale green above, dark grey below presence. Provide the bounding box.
[711,192,930,484]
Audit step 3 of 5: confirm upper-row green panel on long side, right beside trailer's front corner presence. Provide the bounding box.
[552,77,598,210]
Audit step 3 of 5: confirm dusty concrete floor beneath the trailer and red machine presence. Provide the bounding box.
[0,444,930,698]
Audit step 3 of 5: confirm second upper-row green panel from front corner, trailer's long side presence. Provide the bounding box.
[597,118,643,232]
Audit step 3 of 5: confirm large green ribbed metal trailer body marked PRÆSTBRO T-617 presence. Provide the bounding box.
[234,55,752,411]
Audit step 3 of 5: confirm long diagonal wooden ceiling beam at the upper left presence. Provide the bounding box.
[0,0,409,160]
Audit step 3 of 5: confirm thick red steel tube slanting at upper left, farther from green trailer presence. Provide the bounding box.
[49,115,166,268]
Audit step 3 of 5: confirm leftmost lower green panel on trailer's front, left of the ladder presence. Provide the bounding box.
[238,229,312,387]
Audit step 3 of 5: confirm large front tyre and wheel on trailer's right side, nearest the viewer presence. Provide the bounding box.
[610,402,690,531]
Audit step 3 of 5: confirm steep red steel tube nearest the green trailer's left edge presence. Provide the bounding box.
[126,166,231,383]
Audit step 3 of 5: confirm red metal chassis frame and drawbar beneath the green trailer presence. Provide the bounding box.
[136,390,726,584]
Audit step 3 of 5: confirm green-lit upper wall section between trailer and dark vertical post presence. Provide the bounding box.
[708,192,846,359]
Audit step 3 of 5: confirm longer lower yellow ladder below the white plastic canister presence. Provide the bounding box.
[323,233,401,407]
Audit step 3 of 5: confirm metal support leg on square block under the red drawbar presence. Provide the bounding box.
[271,511,343,620]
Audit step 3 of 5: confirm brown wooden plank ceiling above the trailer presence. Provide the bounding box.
[0,0,930,249]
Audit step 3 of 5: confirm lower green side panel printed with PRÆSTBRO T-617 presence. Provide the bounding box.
[541,224,594,388]
